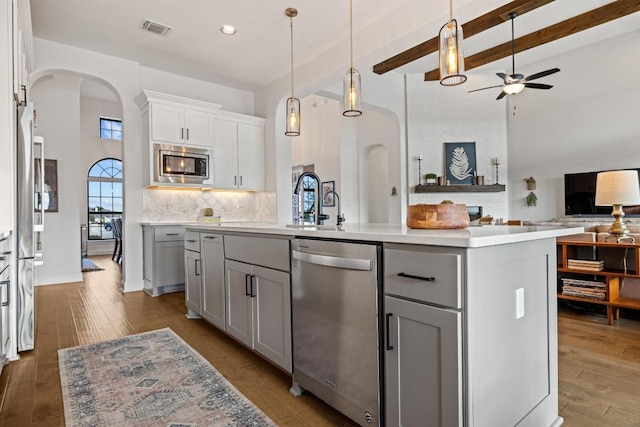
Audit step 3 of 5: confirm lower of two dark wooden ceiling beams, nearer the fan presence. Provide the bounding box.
[424,0,640,81]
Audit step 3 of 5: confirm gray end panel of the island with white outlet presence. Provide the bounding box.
[465,239,559,427]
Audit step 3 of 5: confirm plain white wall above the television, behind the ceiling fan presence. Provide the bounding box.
[508,31,640,220]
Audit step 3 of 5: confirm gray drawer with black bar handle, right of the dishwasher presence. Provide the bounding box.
[384,247,462,308]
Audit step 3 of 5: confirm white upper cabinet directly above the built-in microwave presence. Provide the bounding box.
[138,90,221,148]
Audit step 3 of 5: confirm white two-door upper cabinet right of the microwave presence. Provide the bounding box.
[214,111,264,191]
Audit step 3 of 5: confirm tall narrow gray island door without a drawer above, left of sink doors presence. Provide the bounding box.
[200,233,226,330]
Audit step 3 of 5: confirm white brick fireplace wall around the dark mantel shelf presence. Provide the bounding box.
[407,72,510,219]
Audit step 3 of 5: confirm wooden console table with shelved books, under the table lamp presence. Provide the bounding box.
[557,241,640,325]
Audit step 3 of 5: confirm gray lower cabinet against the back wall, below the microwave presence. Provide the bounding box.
[142,225,185,297]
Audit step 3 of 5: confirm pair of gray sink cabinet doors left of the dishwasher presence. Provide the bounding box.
[225,260,291,372]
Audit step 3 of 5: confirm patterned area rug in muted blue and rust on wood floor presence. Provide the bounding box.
[58,328,275,427]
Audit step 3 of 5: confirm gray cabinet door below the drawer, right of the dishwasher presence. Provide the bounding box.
[385,296,462,427]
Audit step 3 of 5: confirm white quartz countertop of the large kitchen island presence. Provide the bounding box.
[182,222,584,248]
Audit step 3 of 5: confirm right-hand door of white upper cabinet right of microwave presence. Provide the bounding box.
[238,123,264,191]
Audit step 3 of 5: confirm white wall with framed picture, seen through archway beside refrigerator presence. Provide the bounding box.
[31,76,83,285]
